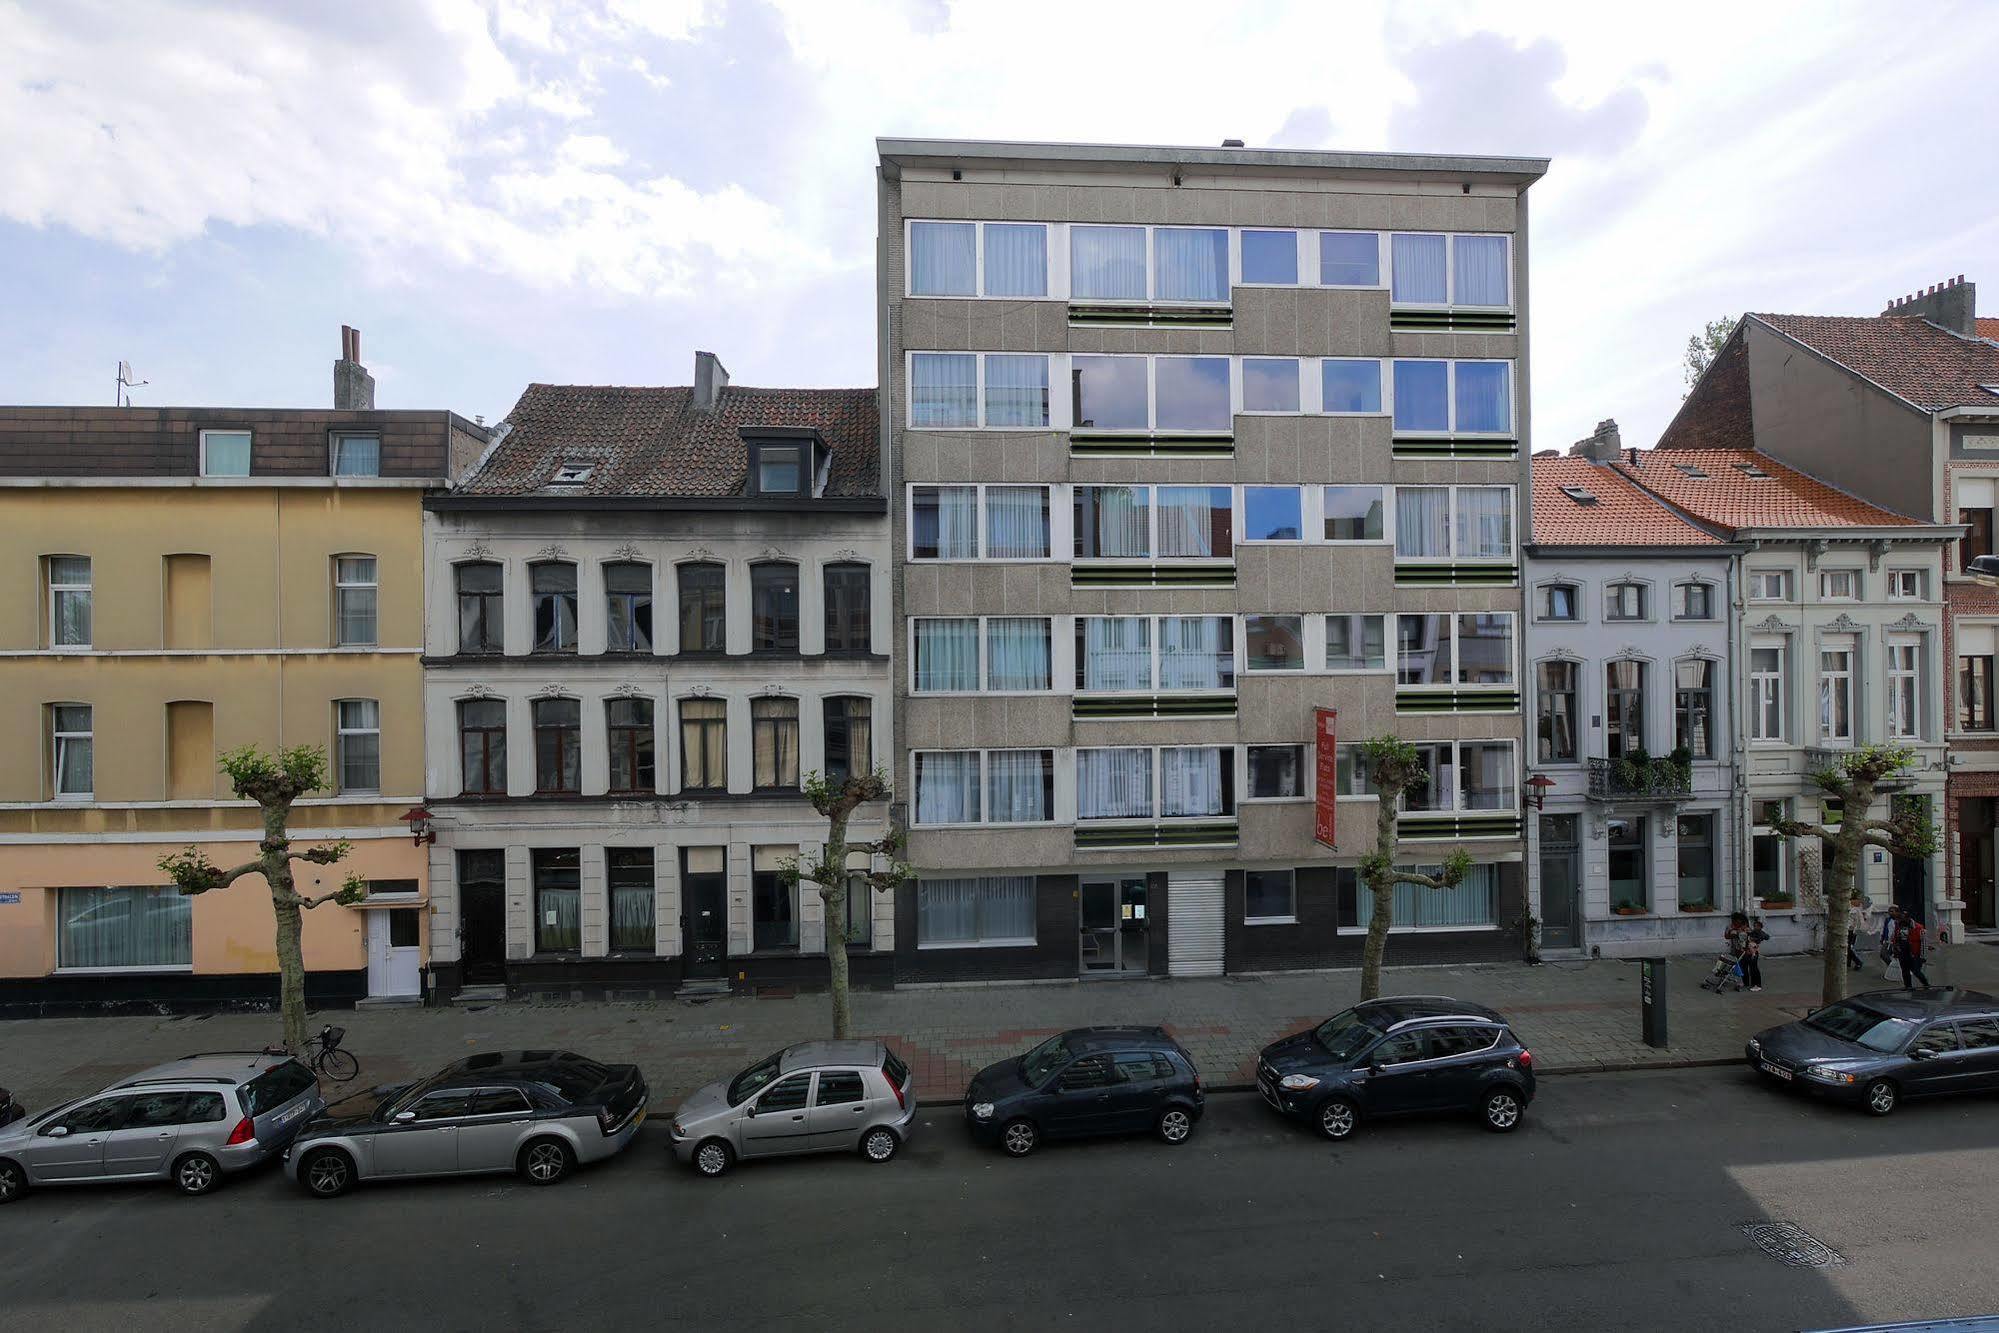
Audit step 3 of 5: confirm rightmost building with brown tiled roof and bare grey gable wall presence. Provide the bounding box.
[1661,278,1999,929]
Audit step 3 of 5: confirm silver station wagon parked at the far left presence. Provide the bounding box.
[0,1051,326,1203]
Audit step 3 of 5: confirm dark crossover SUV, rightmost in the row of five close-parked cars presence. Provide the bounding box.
[1255,995,1533,1139]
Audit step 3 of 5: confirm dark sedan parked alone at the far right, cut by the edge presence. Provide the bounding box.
[1743,989,1999,1115]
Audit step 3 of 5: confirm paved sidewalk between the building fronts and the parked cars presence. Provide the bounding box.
[0,943,1999,1111]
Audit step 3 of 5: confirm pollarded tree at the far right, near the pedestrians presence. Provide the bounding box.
[1771,745,1937,1005]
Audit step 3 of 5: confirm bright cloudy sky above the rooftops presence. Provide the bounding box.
[0,0,1999,448]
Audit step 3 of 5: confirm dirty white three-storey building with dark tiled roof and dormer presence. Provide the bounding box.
[424,352,896,997]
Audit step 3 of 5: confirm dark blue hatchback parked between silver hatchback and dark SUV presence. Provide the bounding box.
[966,1027,1205,1157]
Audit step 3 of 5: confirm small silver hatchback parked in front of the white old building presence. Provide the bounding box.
[672,1041,916,1175]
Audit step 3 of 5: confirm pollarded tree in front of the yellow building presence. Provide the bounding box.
[160,745,368,1055]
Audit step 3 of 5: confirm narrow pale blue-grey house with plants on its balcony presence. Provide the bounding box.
[1527,433,1749,957]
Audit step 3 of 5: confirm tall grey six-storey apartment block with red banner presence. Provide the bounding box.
[878,140,1547,981]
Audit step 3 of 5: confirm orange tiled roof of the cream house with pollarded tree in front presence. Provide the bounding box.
[1615,450,1921,530]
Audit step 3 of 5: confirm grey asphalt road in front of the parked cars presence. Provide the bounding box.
[0,1069,1999,1333]
